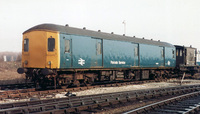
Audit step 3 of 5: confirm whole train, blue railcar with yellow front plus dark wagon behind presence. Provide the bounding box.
[17,24,198,88]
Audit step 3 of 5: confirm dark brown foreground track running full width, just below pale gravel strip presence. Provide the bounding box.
[0,85,200,113]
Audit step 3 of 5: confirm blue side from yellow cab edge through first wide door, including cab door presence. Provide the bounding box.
[60,34,102,68]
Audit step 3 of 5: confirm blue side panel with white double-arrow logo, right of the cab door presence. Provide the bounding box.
[72,35,102,68]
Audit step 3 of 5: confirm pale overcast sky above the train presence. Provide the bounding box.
[0,0,200,52]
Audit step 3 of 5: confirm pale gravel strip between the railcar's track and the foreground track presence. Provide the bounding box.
[0,80,200,103]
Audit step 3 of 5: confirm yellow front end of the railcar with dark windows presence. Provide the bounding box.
[22,31,60,68]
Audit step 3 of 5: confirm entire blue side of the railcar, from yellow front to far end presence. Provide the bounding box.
[60,33,176,68]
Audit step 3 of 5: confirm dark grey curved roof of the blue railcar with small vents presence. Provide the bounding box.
[23,24,174,47]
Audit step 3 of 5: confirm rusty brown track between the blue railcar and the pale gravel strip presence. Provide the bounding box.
[0,80,157,100]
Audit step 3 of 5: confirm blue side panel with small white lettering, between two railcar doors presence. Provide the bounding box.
[103,39,134,68]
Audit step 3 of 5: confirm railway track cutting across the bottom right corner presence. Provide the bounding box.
[124,91,200,114]
